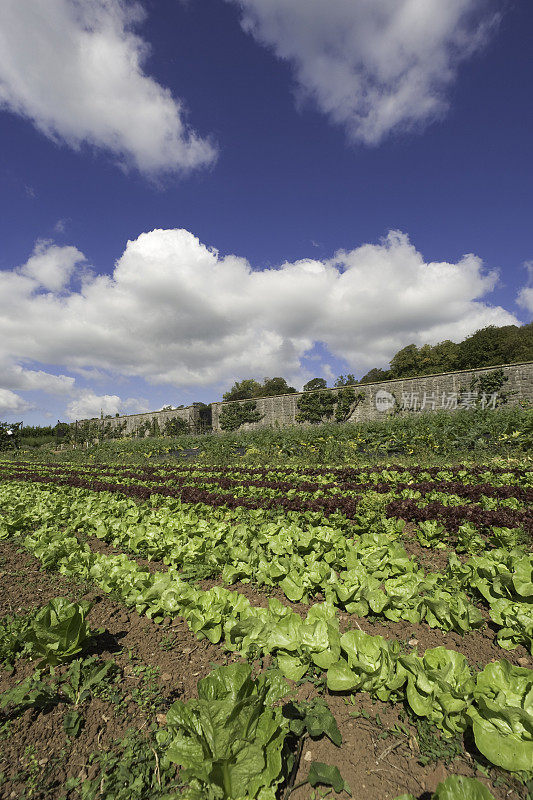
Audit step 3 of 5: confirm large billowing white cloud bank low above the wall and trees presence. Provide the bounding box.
[0,230,518,396]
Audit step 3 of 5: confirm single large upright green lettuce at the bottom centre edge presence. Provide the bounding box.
[160,664,288,800]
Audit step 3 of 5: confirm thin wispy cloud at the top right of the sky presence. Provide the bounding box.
[228,0,497,144]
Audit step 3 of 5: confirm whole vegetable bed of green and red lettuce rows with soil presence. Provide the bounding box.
[0,461,533,800]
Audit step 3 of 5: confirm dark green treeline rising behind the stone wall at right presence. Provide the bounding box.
[223,322,533,400]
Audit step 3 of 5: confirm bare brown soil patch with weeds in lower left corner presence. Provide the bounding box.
[0,542,233,800]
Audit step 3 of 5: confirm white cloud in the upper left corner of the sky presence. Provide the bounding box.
[0,0,215,173]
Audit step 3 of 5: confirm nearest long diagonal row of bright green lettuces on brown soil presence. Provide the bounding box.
[4,494,533,773]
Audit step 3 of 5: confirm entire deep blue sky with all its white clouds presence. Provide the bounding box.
[0,0,533,424]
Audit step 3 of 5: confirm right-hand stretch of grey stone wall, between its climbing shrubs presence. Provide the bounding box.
[211,361,533,433]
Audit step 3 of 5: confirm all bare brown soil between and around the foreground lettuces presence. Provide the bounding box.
[0,538,533,800]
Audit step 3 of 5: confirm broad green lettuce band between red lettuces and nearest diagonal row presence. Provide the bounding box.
[0,483,533,654]
